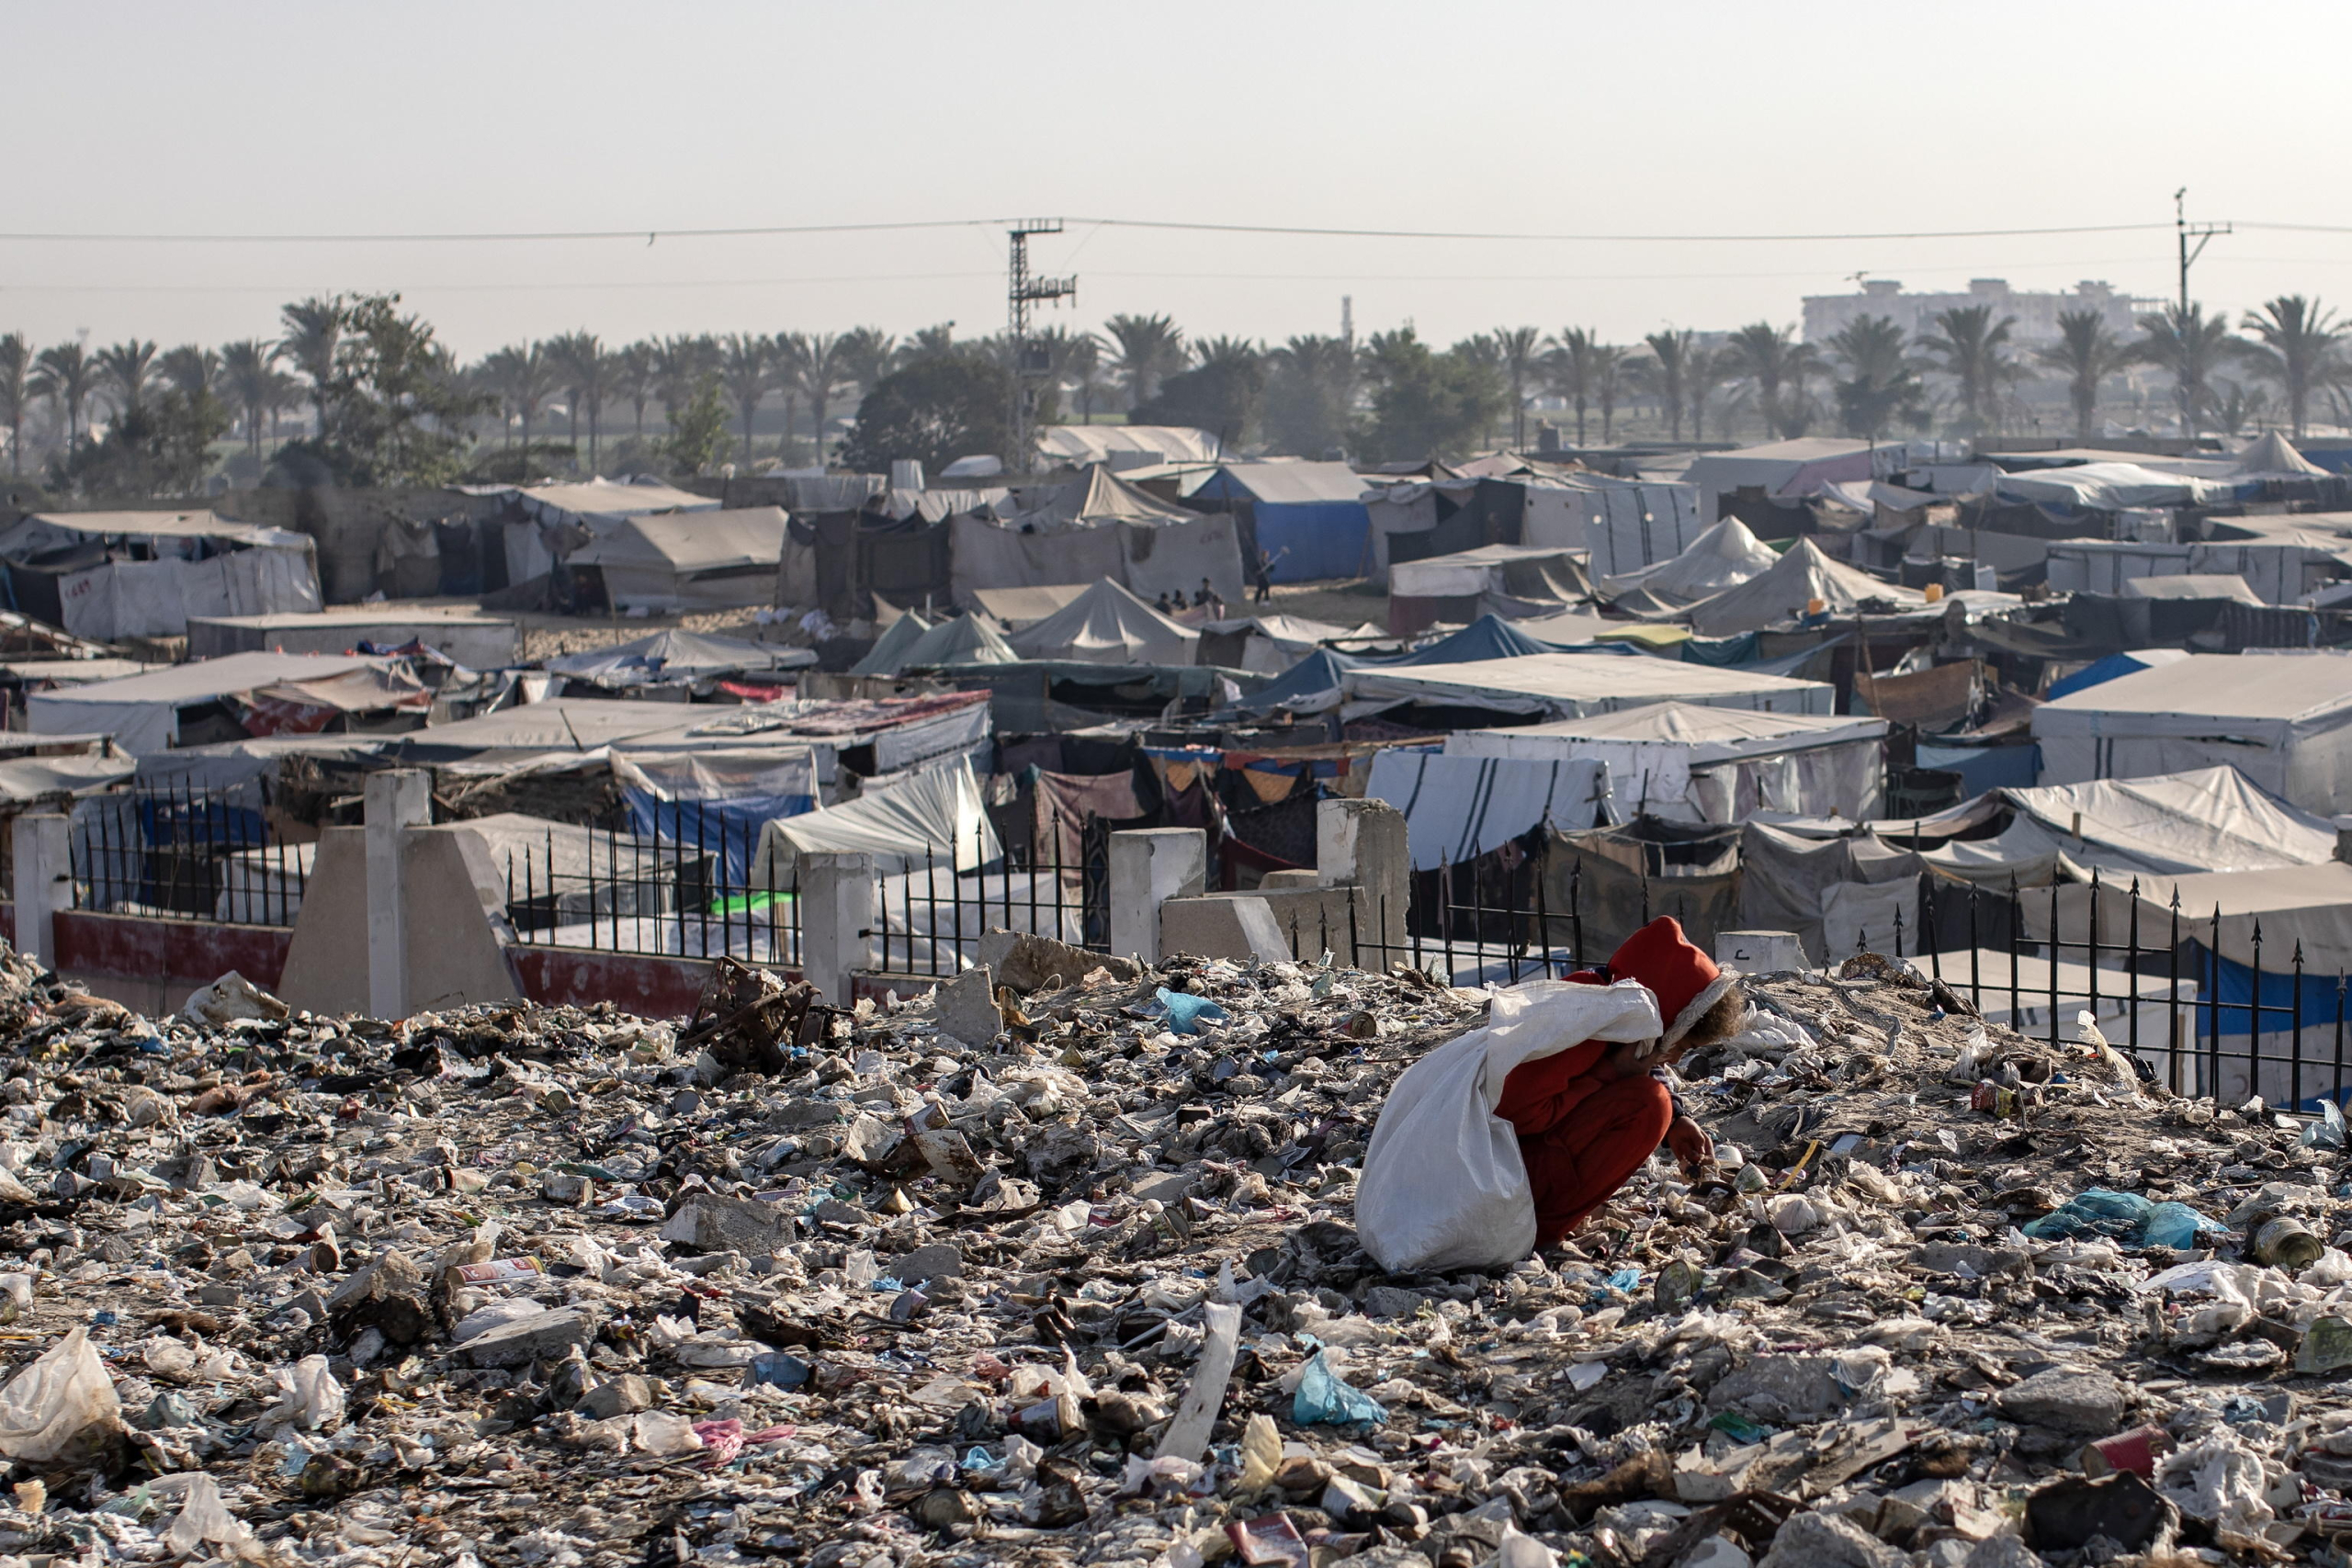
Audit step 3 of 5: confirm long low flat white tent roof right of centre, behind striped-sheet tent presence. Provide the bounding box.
[1340,653,1837,719]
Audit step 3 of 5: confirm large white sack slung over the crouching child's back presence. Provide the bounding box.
[1355,980,1663,1274]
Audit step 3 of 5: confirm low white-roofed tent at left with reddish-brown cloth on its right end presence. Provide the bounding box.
[26,653,433,757]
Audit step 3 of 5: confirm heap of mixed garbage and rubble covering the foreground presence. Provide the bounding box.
[0,938,2352,1568]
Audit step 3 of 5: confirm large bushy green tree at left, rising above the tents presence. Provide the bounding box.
[280,294,492,487]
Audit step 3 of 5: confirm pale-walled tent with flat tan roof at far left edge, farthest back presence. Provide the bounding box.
[0,513,322,642]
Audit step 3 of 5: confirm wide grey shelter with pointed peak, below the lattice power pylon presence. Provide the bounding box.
[948,463,1244,606]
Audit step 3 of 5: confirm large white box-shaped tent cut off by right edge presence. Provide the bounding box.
[2032,651,2352,813]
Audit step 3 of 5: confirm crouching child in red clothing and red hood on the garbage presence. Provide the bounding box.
[1494,917,1747,1248]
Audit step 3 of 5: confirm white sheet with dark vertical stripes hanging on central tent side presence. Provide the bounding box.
[1364,748,1609,872]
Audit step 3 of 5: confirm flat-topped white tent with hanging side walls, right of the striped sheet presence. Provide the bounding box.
[1446,703,1886,825]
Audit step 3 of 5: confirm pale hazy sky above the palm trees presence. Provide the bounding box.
[0,0,2352,357]
